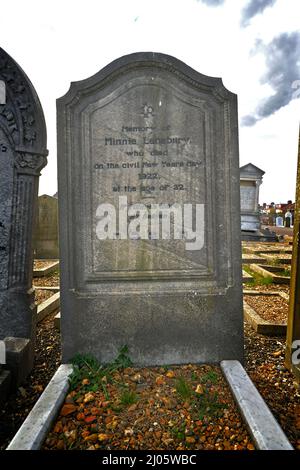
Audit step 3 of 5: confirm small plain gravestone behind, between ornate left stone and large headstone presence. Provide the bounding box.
[34,194,59,259]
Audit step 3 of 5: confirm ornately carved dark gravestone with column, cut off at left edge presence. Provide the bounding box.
[0,49,47,373]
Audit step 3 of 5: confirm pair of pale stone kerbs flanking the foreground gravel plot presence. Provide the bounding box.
[6,361,293,450]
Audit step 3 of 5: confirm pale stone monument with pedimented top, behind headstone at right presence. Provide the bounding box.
[240,163,276,241]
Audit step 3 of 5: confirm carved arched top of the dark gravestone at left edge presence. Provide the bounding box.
[0,48,48,158]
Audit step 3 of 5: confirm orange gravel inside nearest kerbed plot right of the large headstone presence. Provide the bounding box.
[244,295,289,325]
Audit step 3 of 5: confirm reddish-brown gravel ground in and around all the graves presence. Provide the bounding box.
[0,244,300,450]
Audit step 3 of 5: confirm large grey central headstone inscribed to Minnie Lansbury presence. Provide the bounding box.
[57,53,243,365]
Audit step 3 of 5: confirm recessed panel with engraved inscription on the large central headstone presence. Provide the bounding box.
[84,80,214,275]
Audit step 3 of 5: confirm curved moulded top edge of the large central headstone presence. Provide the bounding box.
[57,52,236,107]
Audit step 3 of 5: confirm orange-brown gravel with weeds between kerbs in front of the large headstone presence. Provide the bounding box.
[43,364,254,450]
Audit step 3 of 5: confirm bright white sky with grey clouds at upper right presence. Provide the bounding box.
[0,0,300,203]
